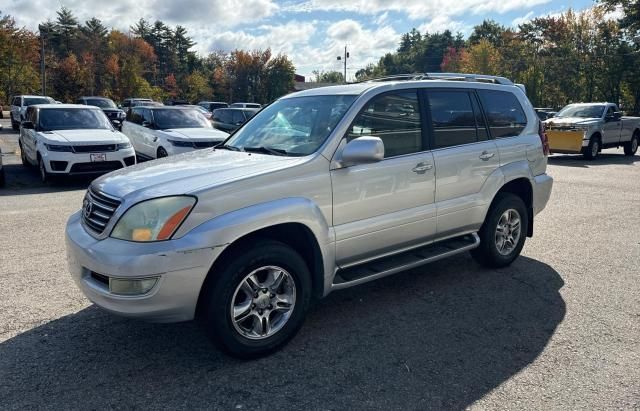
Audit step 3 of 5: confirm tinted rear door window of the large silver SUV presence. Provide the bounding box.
[427,90,487,149]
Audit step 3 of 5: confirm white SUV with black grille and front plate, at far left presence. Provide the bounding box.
[18,104,136,182]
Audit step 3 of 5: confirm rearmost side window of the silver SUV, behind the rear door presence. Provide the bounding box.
[478,90,527,138]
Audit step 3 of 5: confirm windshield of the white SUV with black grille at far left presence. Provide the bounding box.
[38,108,112,131]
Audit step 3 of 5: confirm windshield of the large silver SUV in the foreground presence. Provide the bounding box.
[225,95,356,156]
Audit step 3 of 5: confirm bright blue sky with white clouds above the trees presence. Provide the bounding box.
[0,0,594,79]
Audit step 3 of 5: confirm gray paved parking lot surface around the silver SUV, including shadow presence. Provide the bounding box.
[0,119,640,409]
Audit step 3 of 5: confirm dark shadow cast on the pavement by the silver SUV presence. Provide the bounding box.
[0,257,565,409]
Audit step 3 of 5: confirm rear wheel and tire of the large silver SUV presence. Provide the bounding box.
[471,193,529,268]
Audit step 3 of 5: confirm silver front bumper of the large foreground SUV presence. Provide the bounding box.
[65,212,222,322]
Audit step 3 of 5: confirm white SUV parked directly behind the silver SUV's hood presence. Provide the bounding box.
[122,106,228,160]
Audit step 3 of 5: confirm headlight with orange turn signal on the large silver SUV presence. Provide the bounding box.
[111,196,196,242]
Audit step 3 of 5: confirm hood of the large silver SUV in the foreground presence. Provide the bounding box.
[92,149,307,198]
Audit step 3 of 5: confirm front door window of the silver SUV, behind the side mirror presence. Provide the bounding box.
[347,90,424,158]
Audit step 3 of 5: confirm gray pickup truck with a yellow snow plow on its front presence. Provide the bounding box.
[544,103,640,160]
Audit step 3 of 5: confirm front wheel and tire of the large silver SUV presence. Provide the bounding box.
[198,240,311,359]
